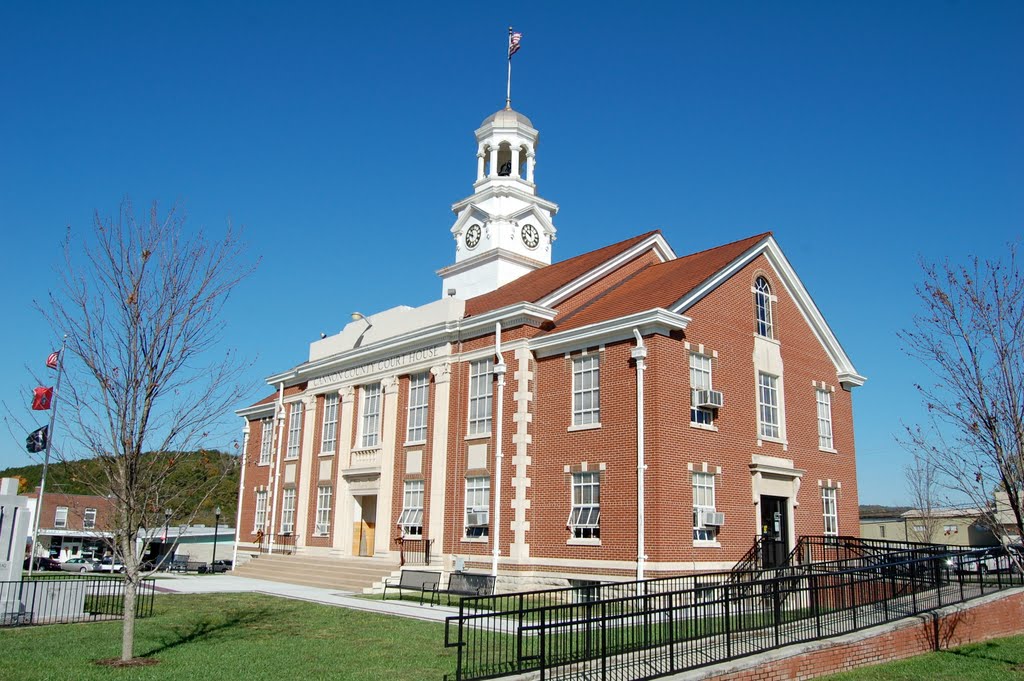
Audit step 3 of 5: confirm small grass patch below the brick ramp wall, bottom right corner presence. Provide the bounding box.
[821,636,1024,681]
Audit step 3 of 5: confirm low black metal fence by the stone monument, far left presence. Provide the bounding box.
[0,576,156,627]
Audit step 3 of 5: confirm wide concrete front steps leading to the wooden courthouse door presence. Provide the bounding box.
[231,553,398,594]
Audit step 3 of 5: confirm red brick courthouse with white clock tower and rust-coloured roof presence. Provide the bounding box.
[238,104,864,582]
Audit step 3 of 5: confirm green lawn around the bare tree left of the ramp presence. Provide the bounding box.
[0,594,455,681]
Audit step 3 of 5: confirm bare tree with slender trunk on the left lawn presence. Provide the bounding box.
[37,200,253,662]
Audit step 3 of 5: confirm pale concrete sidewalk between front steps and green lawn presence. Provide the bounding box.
[154,574,459,622]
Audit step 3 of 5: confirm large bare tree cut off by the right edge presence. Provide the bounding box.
[899,248,1024,540]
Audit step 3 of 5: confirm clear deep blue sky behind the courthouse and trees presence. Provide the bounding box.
[0,2,1024,503]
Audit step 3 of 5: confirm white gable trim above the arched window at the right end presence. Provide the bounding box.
[671,236,867,389]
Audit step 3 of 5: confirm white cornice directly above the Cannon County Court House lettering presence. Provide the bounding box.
[260,303,556,387]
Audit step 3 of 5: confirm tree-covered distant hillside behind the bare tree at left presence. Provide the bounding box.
[0,451,240,525]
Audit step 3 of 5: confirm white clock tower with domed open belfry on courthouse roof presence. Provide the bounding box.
[437,108,558,299]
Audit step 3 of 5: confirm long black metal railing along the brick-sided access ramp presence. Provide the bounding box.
[445,538,1024,681]
